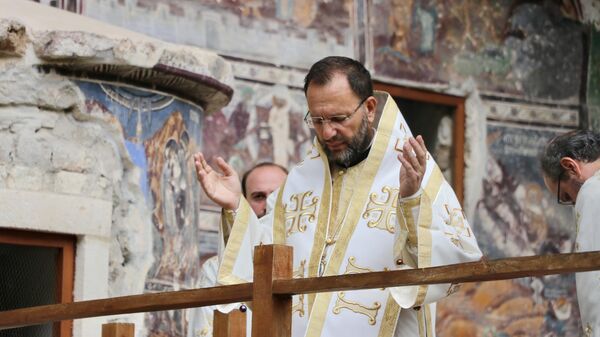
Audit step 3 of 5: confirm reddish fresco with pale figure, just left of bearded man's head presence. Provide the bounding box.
[202,80,312,205]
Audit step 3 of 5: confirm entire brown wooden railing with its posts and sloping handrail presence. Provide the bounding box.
[0,245,600,337]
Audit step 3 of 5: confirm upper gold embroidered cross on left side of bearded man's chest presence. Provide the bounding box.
[283,191,319,237]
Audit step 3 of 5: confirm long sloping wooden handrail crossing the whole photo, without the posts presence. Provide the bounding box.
[0,252,600,330]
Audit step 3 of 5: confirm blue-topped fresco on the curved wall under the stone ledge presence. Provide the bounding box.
[78,81,211,336]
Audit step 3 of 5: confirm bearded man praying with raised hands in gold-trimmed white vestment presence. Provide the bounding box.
[195,57,481,337]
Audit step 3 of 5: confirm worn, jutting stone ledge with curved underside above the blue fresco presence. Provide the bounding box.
[0,0,233,113]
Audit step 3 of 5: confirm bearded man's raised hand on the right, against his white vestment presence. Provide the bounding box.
[398,136,427,198]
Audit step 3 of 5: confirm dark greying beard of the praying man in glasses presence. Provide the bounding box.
[319,115,372,167]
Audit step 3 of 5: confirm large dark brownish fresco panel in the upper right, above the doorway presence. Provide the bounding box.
[371,0,583,101]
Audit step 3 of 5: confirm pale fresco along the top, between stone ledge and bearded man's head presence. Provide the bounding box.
[49,0,355,68]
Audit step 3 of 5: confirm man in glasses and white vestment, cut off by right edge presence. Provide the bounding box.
[541,130,600,337]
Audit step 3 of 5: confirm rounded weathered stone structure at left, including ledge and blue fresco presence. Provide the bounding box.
[0,1,232,336]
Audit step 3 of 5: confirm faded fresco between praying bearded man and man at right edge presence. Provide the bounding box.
[437,122,581,337]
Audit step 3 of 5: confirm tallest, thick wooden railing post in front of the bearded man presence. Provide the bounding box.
[252,245,292,337]
